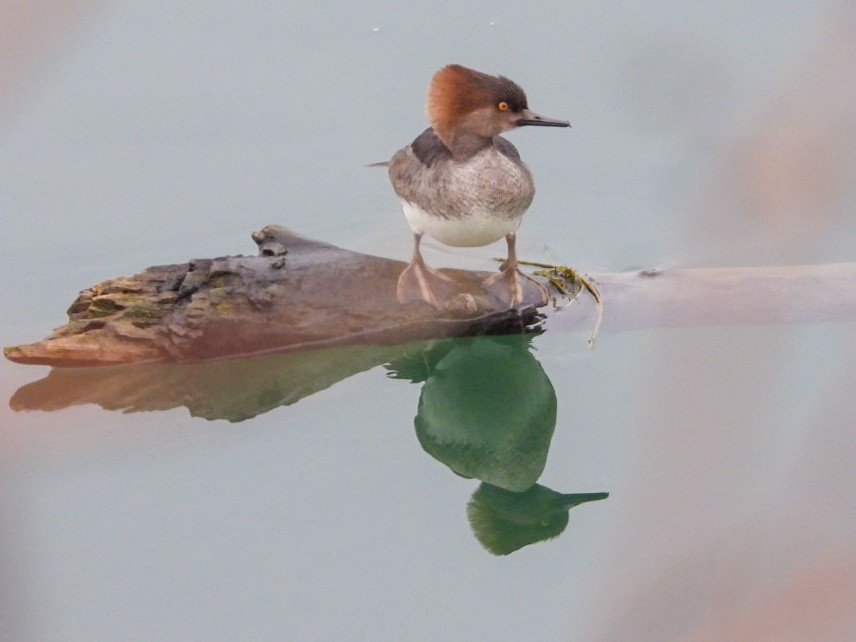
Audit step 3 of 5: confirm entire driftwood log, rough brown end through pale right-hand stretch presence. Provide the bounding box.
[4,226,856,366]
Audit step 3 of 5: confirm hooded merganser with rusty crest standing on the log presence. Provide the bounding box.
[389,65,570,307]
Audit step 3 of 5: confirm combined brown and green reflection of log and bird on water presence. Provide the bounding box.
[9,332,606,554]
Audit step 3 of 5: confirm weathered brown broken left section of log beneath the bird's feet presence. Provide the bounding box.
[4,225,560,366]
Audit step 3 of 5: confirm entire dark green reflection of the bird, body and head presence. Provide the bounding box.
[387,334,607,555]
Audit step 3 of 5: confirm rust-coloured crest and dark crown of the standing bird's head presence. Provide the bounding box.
[426,65,527,132]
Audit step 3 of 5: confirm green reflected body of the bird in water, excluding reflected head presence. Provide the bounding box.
[388,334,556,492]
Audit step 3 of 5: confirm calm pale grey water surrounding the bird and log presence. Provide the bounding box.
[0,0,856,640]
